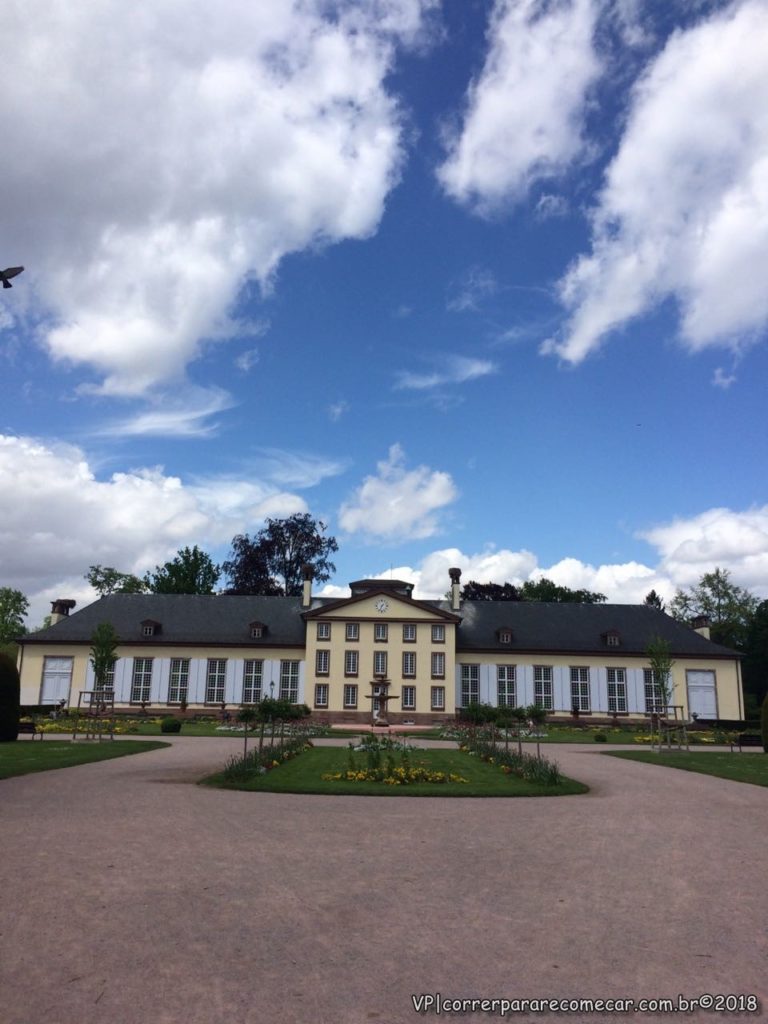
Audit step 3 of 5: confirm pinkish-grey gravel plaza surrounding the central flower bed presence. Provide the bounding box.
[0,737,768,1024]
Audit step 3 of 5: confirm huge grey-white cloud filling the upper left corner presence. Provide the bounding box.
[0,0,435,394]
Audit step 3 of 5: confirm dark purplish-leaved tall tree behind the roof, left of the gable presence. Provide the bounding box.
[223,512,339,596]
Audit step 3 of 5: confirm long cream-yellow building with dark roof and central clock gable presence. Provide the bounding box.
[19,569,743,724]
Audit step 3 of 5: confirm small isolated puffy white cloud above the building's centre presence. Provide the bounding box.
[339,444,458,542]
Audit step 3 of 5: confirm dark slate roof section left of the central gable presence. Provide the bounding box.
[23,594,305,647]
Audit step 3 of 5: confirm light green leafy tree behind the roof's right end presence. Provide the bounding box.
[670,568,759,650]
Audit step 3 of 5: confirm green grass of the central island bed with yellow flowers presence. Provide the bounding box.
[203,746,588,797]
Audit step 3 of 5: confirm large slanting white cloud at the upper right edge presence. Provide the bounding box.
[544,0,768,362]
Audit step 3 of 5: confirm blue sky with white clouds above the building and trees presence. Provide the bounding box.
[0,0,768,628]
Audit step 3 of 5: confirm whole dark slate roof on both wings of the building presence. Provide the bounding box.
[23,594,739,658]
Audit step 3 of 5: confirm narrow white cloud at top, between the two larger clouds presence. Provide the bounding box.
[438,0,600,212]
